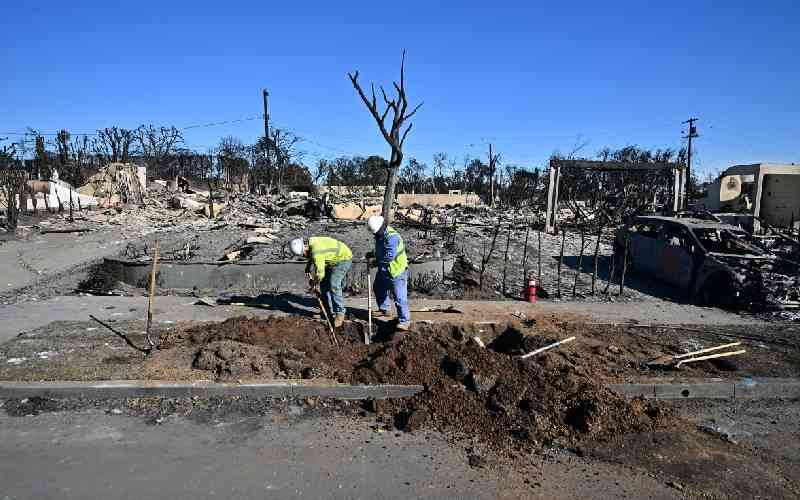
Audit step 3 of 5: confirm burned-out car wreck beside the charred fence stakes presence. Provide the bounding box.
[614,216,800,309]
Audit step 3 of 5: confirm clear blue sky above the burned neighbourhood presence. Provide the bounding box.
[0,0,800,178]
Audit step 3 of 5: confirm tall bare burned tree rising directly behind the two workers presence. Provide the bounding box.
[347,50,422,224]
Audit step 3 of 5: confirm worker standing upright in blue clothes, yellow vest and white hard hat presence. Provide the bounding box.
[367,215,411,331]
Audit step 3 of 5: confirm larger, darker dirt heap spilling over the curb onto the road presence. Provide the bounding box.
[354,320,669,450]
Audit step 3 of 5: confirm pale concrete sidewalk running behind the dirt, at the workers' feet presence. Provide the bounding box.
[0,294,762,342]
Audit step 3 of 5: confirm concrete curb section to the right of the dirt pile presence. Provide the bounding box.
[608,377,800,400]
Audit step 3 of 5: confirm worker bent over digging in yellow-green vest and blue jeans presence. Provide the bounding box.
[289,236,353,328]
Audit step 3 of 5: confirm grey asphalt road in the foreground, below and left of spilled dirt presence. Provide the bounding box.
[0,407,678,500]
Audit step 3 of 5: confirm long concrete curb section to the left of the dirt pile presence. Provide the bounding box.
[0,380,423,399]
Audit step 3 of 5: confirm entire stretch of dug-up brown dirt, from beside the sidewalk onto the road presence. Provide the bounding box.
[153,317,672,454]
